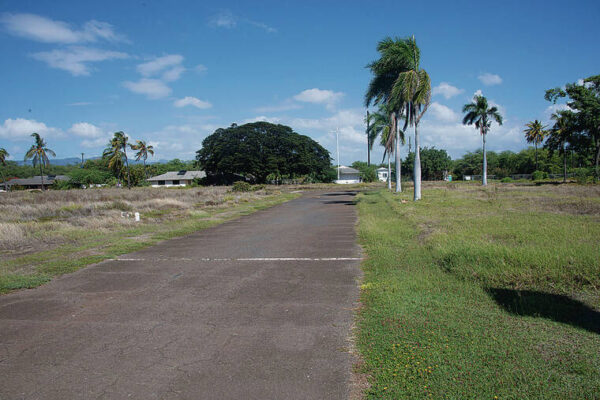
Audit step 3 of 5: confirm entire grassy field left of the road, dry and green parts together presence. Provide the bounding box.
[0,185,298,293]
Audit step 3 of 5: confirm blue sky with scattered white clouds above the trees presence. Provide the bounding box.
[0,0,600,164]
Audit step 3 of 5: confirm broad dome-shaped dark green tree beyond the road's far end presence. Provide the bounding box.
[196,122,331,183]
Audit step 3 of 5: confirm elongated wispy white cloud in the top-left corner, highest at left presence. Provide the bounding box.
[0,13,126,44]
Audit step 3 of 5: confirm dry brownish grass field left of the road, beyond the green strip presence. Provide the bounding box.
[0,187,288,256]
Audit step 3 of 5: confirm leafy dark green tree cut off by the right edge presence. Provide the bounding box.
[545,75,600,180]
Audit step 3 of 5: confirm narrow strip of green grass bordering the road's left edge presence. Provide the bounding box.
[0,193,299,294]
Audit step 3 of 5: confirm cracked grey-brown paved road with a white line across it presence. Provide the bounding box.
[0,192,360,400]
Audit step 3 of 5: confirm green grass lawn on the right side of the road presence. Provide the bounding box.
[357,185,600,399]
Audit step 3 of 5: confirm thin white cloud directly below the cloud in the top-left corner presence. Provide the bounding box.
[31,46,129,76]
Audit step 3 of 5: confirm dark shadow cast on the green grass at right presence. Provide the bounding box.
[487,288,600,334]
